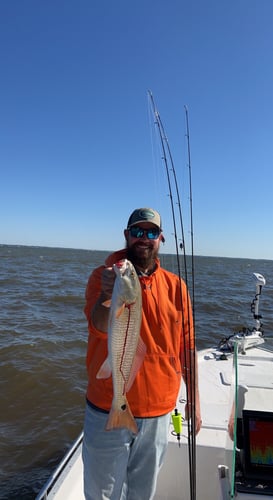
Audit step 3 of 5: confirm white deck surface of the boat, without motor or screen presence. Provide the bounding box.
[36,344,273,500]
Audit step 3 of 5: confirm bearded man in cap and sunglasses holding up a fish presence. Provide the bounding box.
[83,208,201,500]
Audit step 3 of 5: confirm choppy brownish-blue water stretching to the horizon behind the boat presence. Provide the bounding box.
[0,245,273,500]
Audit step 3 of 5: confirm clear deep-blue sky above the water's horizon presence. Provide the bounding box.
[0,0,273,260]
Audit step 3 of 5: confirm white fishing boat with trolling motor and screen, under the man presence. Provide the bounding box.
[36,273,273,500]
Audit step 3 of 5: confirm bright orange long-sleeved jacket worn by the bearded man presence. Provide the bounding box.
[84,250,194,417]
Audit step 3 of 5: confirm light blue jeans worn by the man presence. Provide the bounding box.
[82,405,170,500]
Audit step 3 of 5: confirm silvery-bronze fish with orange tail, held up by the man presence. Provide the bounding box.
[96,259,146,434]
